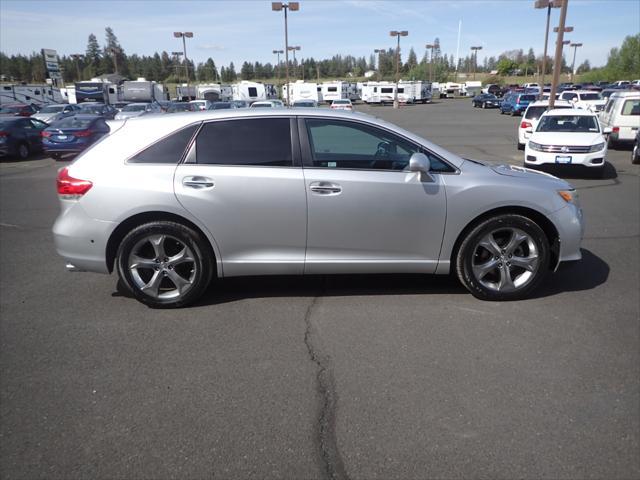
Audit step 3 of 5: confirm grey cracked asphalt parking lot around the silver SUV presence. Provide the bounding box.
[0,100,640,480]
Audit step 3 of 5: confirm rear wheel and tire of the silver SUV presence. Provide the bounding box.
[116,221,214,308]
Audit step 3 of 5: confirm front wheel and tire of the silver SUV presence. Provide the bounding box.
[456,214,549,301]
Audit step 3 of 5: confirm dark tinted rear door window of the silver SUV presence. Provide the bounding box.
[196,118,293,167]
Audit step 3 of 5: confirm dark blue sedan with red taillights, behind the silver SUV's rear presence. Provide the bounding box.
[42,114,110,160]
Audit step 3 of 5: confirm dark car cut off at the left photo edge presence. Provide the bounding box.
[0,116,47,160]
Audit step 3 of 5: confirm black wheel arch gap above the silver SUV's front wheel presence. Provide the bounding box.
[449,206,560,270]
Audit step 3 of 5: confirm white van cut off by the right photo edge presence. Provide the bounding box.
[600,91,640,147]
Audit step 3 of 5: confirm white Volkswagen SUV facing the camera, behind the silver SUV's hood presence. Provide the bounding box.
[524,108,611,175]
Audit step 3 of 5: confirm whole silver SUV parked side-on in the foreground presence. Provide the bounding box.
[53,109,583,307]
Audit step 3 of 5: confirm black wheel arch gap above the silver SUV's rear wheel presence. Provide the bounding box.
[105,211,222,277]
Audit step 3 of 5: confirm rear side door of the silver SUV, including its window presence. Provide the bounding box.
[174,116,307,276]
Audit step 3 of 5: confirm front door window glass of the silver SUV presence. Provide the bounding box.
[305,119,453,172]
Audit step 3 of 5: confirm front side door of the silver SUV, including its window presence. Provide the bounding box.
[298,117,448,273]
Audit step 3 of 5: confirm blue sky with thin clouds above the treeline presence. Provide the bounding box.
[0,0,640,70]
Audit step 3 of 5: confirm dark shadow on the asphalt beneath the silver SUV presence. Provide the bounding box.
[112,249,609,307]
